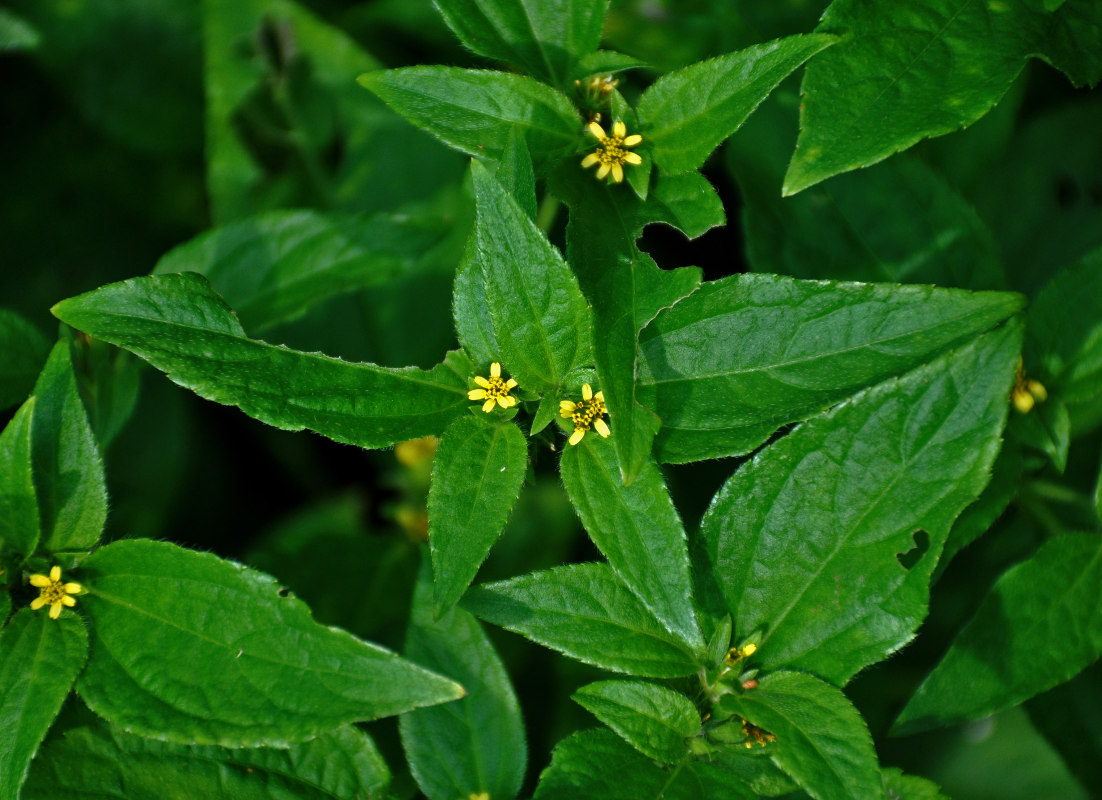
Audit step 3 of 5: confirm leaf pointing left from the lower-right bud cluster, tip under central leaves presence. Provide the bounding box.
[462,564,700,678]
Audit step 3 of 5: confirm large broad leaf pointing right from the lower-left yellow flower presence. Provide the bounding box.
[77,539,463,747]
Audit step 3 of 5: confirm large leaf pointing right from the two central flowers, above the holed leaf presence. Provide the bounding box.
[638,274,1022,464]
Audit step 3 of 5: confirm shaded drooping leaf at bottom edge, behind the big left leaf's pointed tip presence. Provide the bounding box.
[399,557,528,800]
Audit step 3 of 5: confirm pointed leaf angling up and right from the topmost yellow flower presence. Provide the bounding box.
[636,33,836,173]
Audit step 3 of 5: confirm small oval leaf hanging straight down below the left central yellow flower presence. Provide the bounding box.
[429,411,528,616]
